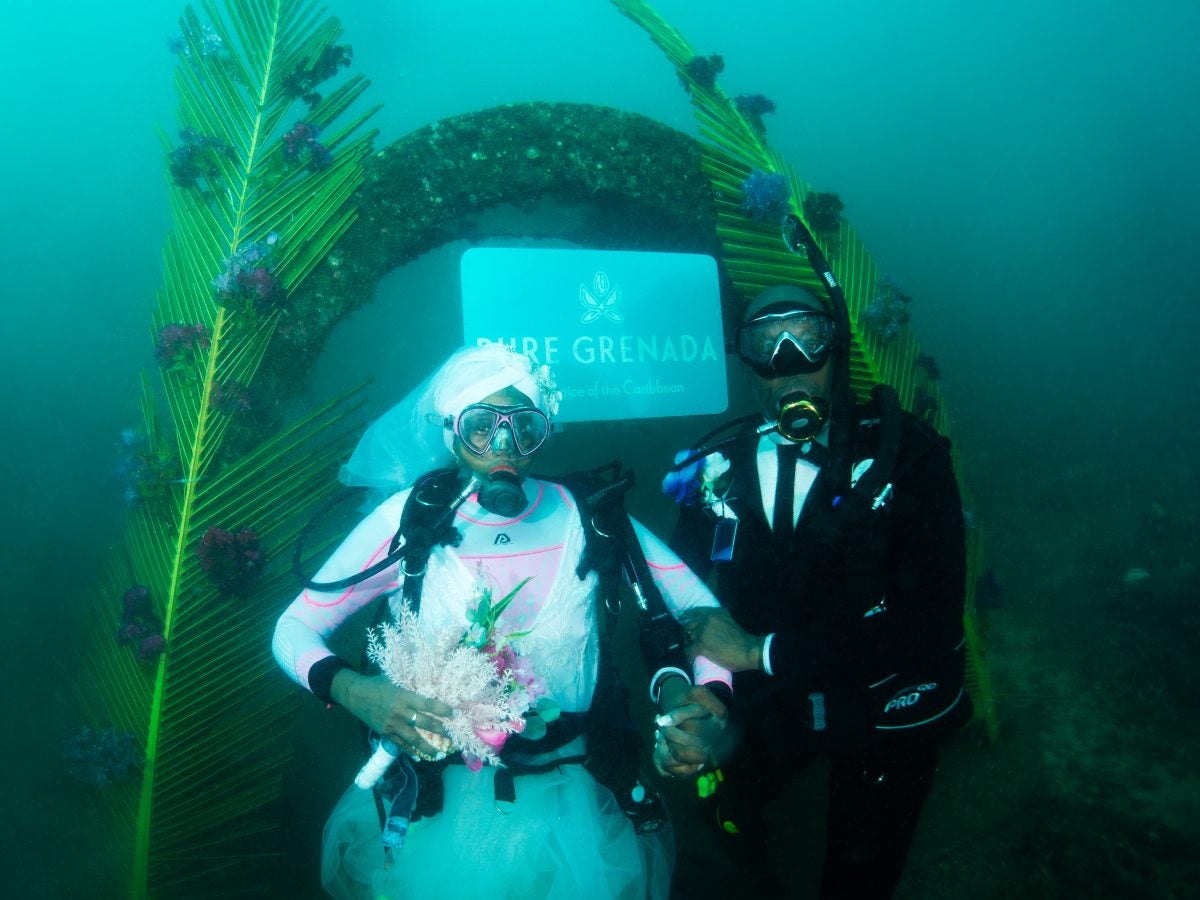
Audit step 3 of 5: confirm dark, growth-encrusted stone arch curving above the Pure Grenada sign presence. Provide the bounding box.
[256,102,724,407]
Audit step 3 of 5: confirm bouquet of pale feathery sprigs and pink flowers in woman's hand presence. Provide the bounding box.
[367,580,540,770]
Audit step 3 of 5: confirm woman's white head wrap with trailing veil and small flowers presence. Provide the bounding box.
[340,343,563,493]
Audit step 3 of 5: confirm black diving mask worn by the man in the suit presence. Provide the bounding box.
[733,308,834,378]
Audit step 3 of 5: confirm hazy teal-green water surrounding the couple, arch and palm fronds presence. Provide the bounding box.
[0,0,1200,899]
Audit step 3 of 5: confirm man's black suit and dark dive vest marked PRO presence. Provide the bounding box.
[672,403,971,900]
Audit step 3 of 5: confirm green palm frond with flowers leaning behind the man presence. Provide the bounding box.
[612,0,997,737]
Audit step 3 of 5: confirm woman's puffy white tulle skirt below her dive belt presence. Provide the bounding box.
[322,764,674,900]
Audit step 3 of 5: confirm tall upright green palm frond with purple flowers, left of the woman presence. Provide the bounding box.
[79,0,374,898]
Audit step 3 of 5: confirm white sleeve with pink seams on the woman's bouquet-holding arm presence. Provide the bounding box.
[271,491,408,688]
